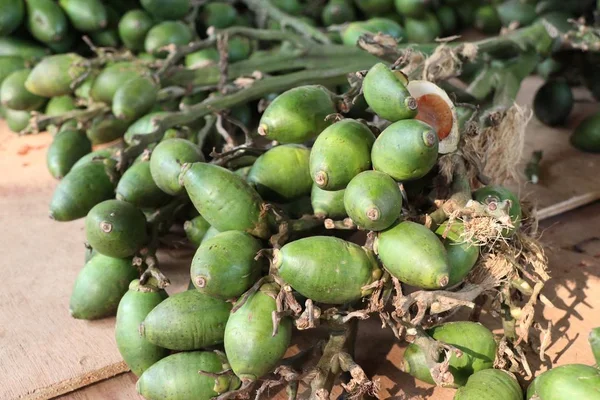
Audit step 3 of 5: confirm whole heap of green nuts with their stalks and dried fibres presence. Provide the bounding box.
[0,0,600,400]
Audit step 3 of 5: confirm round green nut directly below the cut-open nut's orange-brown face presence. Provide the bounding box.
[371,119,438,181]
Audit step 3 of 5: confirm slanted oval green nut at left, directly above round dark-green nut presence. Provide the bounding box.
[50,160,115,221]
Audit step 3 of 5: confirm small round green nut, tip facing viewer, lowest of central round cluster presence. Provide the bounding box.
[344,171,402,231]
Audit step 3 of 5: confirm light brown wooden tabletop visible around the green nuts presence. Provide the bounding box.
[0,79,600,400]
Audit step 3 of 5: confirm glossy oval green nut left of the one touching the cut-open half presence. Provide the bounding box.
[258,85,336,143]
